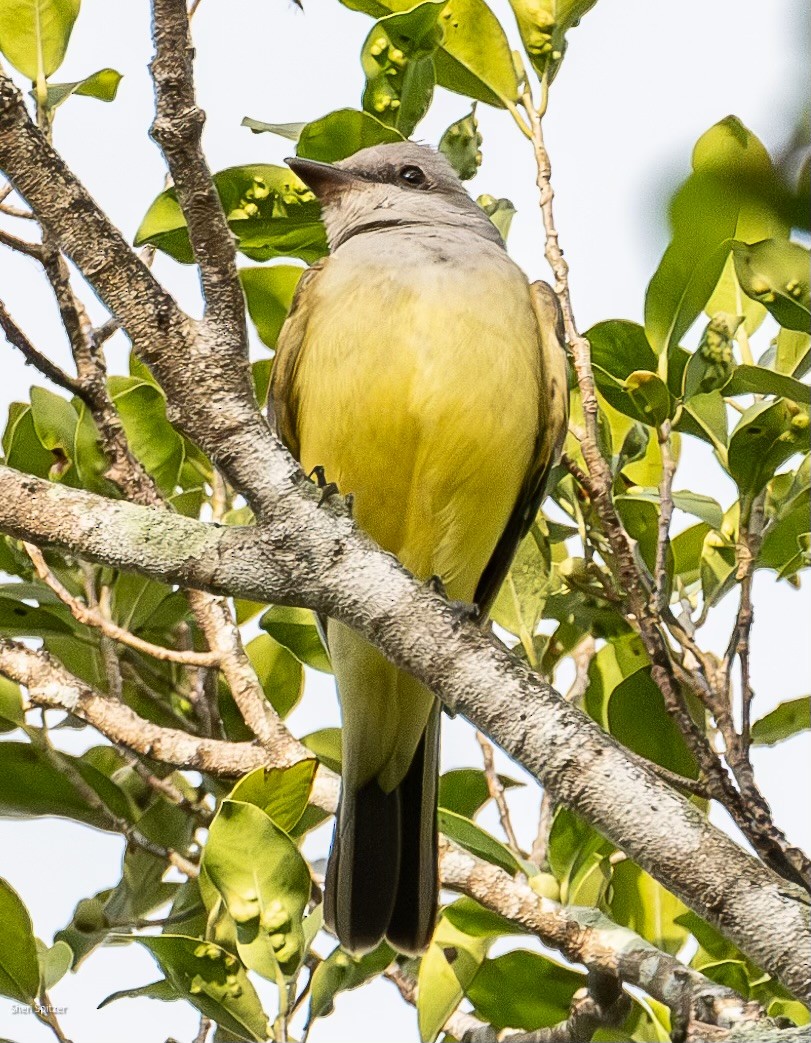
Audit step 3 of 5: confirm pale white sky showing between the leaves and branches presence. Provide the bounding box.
[0,0,811,1043]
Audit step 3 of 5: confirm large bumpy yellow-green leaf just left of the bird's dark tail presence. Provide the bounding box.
[202,800,310,980]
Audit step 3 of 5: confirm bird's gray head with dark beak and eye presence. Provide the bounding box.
[287,141,502,250]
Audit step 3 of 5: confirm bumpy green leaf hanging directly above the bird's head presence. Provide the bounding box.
[361,0,447,138]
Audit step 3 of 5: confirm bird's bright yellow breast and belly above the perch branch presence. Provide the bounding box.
[294,232,540,601]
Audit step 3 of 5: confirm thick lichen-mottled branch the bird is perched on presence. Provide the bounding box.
[0,468,811,998]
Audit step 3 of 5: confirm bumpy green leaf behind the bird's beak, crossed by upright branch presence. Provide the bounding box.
[134,164,327,264]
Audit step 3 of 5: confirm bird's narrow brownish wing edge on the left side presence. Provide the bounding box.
[268,258,329,460]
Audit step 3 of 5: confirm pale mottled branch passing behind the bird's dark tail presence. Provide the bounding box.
[0,638,783,1039]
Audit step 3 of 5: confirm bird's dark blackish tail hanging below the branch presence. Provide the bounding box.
[324,705,440,954]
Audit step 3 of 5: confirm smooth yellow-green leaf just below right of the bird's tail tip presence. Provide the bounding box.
[417,913,490,1043]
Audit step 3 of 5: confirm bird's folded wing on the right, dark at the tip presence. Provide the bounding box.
[473,282,569,618]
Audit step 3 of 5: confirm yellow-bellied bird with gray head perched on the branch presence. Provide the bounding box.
[268,141,568,954]
